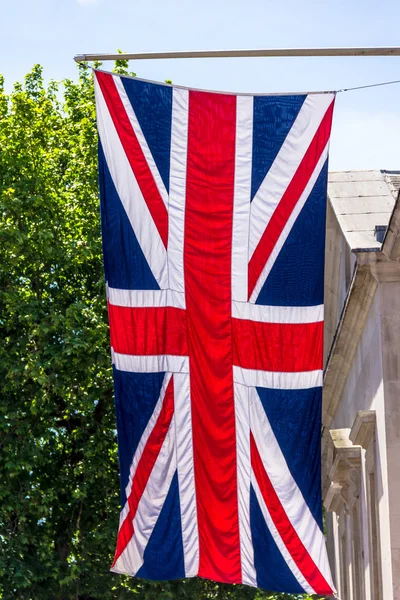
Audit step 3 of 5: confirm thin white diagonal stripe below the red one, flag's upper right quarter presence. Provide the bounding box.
[250,141,329,302]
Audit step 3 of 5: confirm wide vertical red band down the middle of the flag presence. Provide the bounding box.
[184,92,241,583]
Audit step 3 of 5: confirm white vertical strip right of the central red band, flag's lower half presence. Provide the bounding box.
[234,384,257,587]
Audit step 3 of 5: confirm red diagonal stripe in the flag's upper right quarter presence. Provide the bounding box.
[248,101,334,298]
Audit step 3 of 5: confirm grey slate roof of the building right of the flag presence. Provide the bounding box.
[328,171,400,250]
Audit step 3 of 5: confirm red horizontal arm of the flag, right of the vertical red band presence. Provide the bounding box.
[232,319,324,373]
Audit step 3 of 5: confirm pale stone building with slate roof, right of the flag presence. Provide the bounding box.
[322,171,400,600]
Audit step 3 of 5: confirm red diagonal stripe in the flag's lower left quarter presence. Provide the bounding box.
[112,377,174,567]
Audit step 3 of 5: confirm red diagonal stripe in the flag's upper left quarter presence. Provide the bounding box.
[95,71,168,247]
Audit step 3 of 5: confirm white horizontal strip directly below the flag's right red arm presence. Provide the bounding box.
[233,366,323,390]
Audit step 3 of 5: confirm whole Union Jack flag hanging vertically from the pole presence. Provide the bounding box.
[94,70,334,595]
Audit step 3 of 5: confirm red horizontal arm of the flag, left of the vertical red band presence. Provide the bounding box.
[108,304,188,356]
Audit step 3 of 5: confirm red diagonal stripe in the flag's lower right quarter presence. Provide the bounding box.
[250,433,333,596]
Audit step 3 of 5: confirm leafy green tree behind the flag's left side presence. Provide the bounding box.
[0,60,318,600]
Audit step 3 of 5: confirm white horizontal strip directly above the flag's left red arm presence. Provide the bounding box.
[107,285,186,309]
